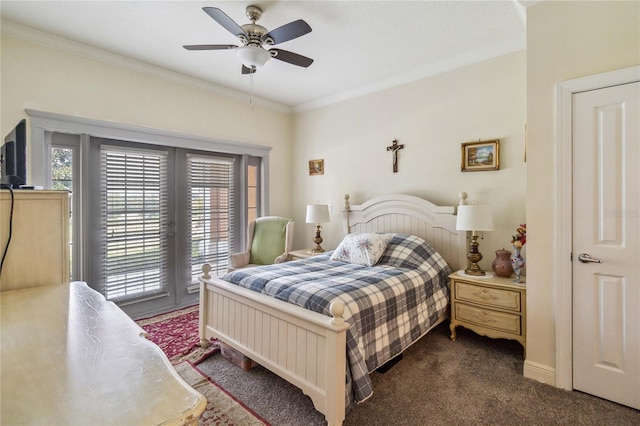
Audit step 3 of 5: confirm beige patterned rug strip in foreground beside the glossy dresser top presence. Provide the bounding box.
[174,362,269,426]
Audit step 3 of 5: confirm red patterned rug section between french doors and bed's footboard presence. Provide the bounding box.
[136,305,219,365]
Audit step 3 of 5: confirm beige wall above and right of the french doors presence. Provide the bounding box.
[0,34,292,215]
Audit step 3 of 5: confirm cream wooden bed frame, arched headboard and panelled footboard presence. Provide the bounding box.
[200,195,467,426]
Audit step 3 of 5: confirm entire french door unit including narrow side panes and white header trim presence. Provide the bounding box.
[27,110,270,317]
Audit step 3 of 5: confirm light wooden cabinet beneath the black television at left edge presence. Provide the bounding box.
[0,189,70,291]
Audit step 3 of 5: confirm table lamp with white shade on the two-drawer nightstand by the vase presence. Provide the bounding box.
[456,204,493,276]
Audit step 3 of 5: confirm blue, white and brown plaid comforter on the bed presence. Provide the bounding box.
[223,234,451,407]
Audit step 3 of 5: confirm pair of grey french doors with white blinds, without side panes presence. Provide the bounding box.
[88,138,241,317]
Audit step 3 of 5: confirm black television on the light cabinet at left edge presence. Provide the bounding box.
[0,119,27,189]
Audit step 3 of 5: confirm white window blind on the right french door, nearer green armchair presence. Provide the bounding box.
[187,154,235,284]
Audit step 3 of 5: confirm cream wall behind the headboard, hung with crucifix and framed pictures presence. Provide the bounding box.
[293,51,527,269]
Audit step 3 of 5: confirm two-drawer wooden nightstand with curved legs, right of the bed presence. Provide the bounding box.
[449,271,527,354]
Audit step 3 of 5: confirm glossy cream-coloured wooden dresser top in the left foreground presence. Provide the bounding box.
[0,282,207,425]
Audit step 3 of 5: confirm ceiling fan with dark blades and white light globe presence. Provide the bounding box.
[183,5,313,74]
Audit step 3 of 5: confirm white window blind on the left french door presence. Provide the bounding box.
[100,146,168,301]
